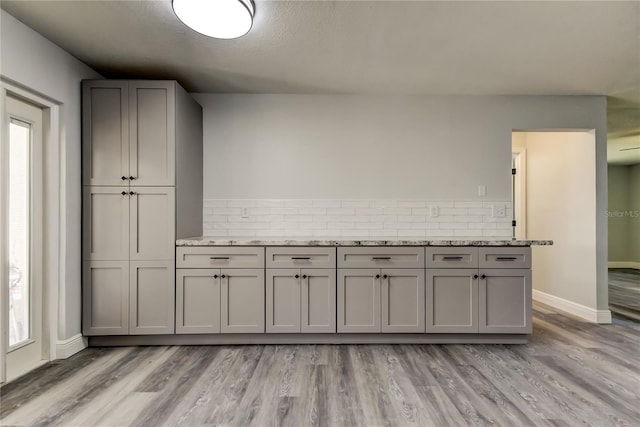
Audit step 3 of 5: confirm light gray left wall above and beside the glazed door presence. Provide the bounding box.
[0,11,101,340]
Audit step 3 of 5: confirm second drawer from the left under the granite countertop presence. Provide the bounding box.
[267,247,336,268]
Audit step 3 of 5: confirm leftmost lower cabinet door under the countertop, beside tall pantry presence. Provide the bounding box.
[176,269,220,334]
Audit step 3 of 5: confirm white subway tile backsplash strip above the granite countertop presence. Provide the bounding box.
[203,199,512,239]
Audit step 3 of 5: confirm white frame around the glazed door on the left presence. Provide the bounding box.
[0,78,61,383]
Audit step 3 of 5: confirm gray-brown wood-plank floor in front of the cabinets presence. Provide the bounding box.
[0,305,640,427]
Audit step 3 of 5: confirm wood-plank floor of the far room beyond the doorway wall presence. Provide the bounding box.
[609,268,640,320]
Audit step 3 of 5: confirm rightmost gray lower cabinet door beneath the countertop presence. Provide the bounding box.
[479,269,531,334]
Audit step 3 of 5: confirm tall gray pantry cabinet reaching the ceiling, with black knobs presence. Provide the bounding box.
[82,80,202,336]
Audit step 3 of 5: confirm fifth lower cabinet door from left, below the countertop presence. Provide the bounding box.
[337,268,381,333]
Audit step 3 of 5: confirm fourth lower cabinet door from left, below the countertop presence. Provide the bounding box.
[300,268,336,333]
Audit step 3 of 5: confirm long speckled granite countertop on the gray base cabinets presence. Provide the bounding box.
[176,236,553,246]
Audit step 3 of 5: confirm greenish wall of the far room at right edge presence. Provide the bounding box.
[608,165,637,262]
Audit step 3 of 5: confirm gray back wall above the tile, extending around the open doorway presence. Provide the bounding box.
[196,94,608,310]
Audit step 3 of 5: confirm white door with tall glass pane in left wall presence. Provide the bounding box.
[0,96,45,381]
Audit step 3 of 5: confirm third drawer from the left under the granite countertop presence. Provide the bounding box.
[338,246,424,268]
